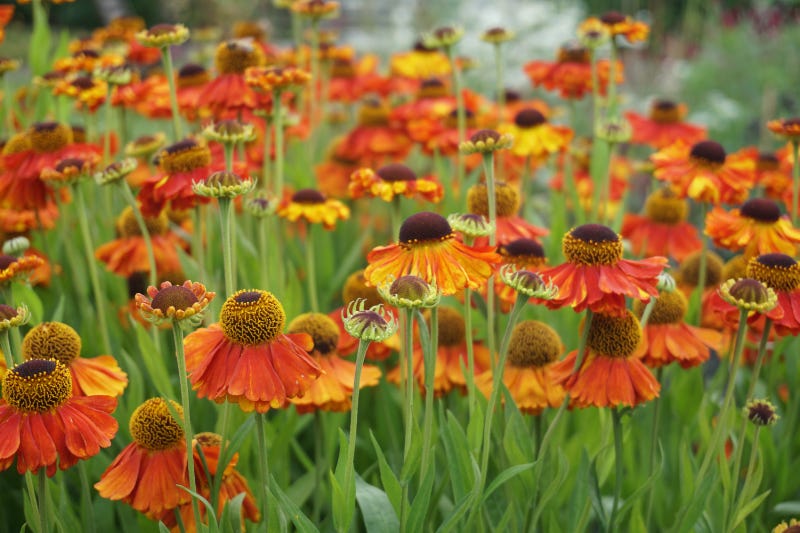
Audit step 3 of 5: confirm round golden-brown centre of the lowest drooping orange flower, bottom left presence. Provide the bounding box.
[129,398,184,451]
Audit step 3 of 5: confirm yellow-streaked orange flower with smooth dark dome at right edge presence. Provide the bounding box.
[705,198,800,258]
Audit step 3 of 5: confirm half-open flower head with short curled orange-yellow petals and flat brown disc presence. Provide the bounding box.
[134,280,216,326]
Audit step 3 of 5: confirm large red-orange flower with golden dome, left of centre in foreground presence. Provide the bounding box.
[184,290,322,413]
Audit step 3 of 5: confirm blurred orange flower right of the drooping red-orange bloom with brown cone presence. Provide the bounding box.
[633,291,723,368]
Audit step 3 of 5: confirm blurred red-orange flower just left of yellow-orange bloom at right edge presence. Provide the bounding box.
[620,188,703,261]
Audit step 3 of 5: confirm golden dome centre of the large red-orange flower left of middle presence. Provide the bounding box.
[219,290,286,346]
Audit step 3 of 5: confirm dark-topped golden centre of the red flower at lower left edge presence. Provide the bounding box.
[3,359,72,413]
